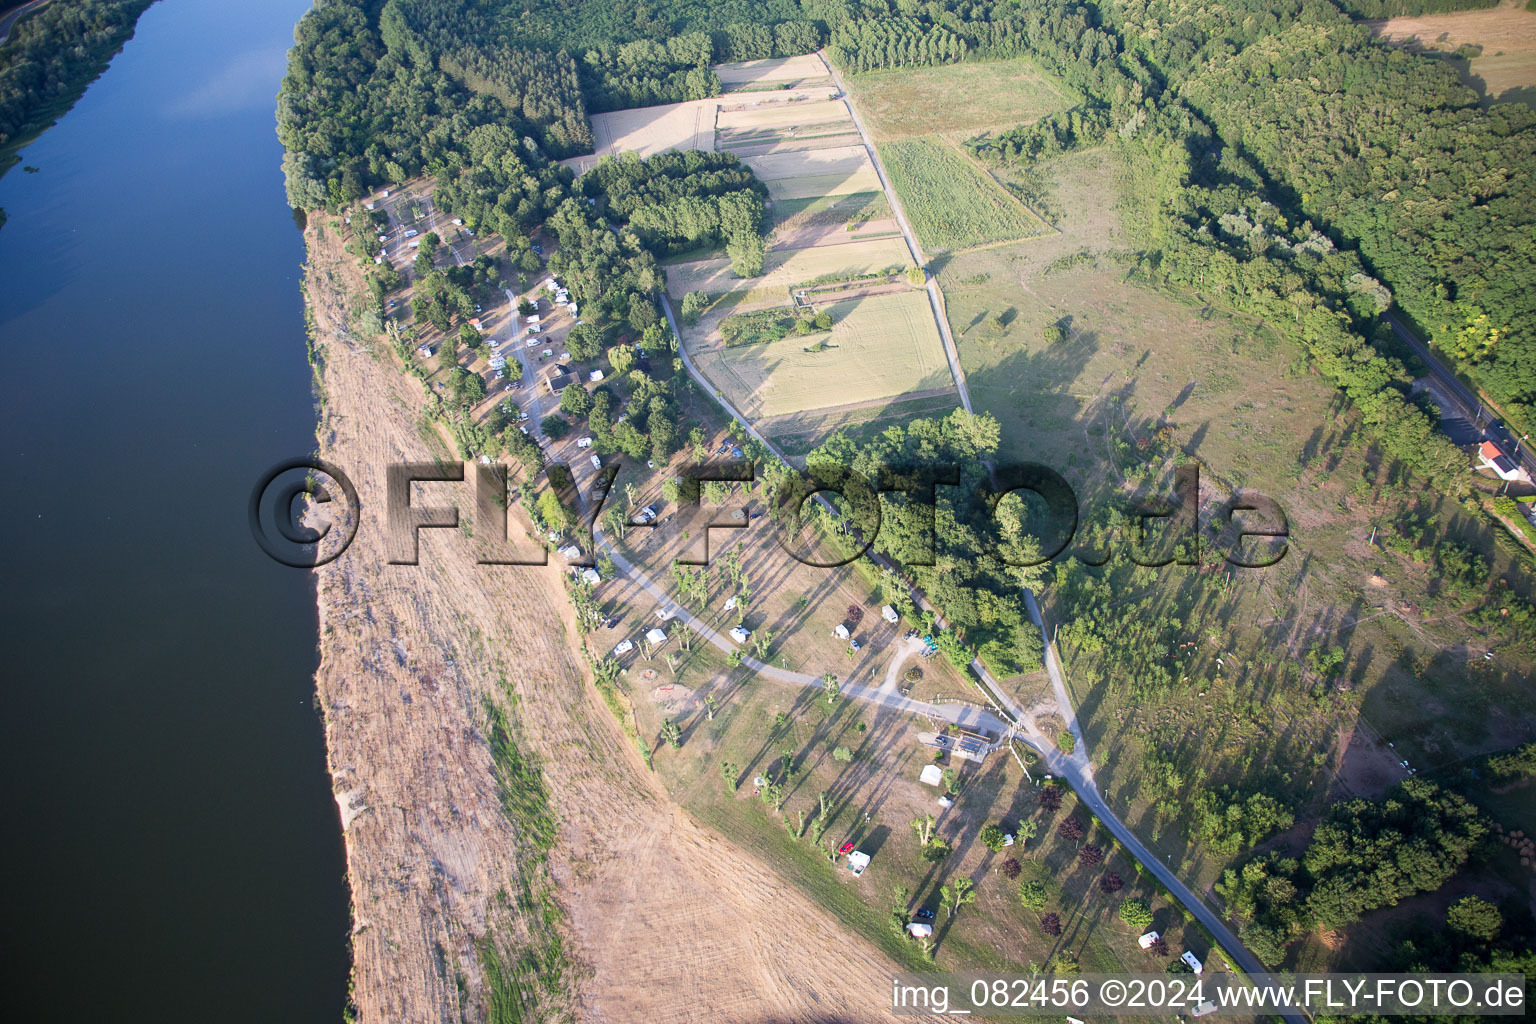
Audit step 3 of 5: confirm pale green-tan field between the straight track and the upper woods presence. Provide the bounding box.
[848,58,1078,141]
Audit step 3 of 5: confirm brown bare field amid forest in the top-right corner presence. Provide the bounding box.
[1362,3,1536,106]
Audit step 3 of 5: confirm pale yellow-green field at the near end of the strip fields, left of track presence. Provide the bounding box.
[696,292,952,418]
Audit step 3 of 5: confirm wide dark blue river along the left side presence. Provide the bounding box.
[0,0,349,1024]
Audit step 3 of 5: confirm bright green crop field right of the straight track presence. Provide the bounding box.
[880,138,1049,249]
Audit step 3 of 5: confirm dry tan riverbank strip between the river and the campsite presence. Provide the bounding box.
[294,216,927,1024]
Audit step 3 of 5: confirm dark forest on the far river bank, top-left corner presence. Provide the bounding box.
[0,0,154,223]
